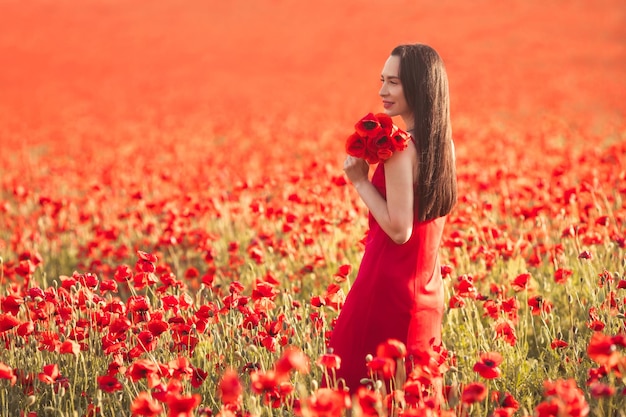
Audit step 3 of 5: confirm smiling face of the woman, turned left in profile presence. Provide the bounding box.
[378,55,413,128]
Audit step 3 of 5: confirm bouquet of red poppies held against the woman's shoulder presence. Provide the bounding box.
[346,113,411,164]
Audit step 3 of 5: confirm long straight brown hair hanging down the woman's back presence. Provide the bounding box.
[391,44,457,221]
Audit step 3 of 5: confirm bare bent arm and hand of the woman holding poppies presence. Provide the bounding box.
[344,143,416,244]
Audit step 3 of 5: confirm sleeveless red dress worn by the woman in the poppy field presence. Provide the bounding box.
[330,163,446,392]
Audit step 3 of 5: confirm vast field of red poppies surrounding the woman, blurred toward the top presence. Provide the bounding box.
[0,0,626,417]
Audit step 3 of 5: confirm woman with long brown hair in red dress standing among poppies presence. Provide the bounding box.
[330,44,456,392]
